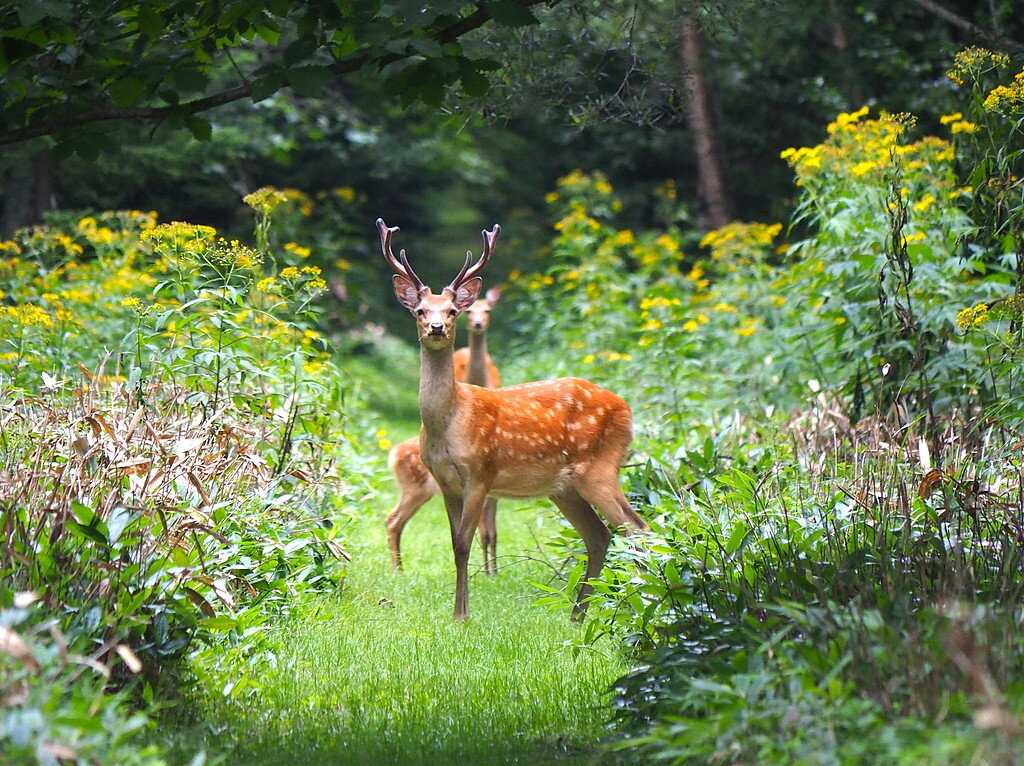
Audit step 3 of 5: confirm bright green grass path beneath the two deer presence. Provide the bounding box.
[190,487,624,766]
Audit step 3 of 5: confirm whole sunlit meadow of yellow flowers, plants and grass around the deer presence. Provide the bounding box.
[0,49,1024,764]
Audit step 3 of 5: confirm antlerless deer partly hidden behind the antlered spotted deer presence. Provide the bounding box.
[384,287,502,575]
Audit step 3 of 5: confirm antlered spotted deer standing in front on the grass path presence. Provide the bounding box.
[377,218,649,622]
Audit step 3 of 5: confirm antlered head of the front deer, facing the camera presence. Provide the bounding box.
[377,218,501,350]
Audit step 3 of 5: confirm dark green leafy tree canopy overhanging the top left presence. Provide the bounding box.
[0,0,558,154]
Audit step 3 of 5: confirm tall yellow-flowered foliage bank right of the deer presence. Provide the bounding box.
[516,62,1024,763]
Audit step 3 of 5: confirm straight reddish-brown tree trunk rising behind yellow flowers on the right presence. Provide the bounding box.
[679,9,732,228]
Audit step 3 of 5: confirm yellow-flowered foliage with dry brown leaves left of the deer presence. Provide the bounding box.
[0,190,380,761]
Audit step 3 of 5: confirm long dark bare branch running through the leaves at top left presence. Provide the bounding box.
[0,0,548,146]
